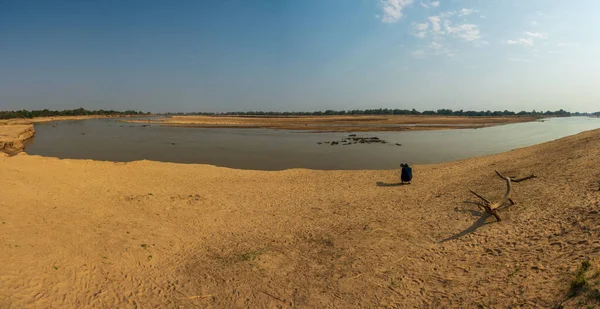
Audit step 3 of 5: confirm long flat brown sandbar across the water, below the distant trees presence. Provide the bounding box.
[128,115,538,132]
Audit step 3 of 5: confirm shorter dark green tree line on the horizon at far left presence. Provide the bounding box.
[0,108,150,119]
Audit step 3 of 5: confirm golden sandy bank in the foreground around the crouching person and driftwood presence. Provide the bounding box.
[0,130,600,308]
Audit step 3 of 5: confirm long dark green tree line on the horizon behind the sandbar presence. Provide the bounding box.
[166,108,600,117]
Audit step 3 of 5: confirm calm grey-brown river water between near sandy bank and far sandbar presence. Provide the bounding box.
[25,117,600,170]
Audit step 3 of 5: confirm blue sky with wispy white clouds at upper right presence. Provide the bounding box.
[0,0,600,112]
